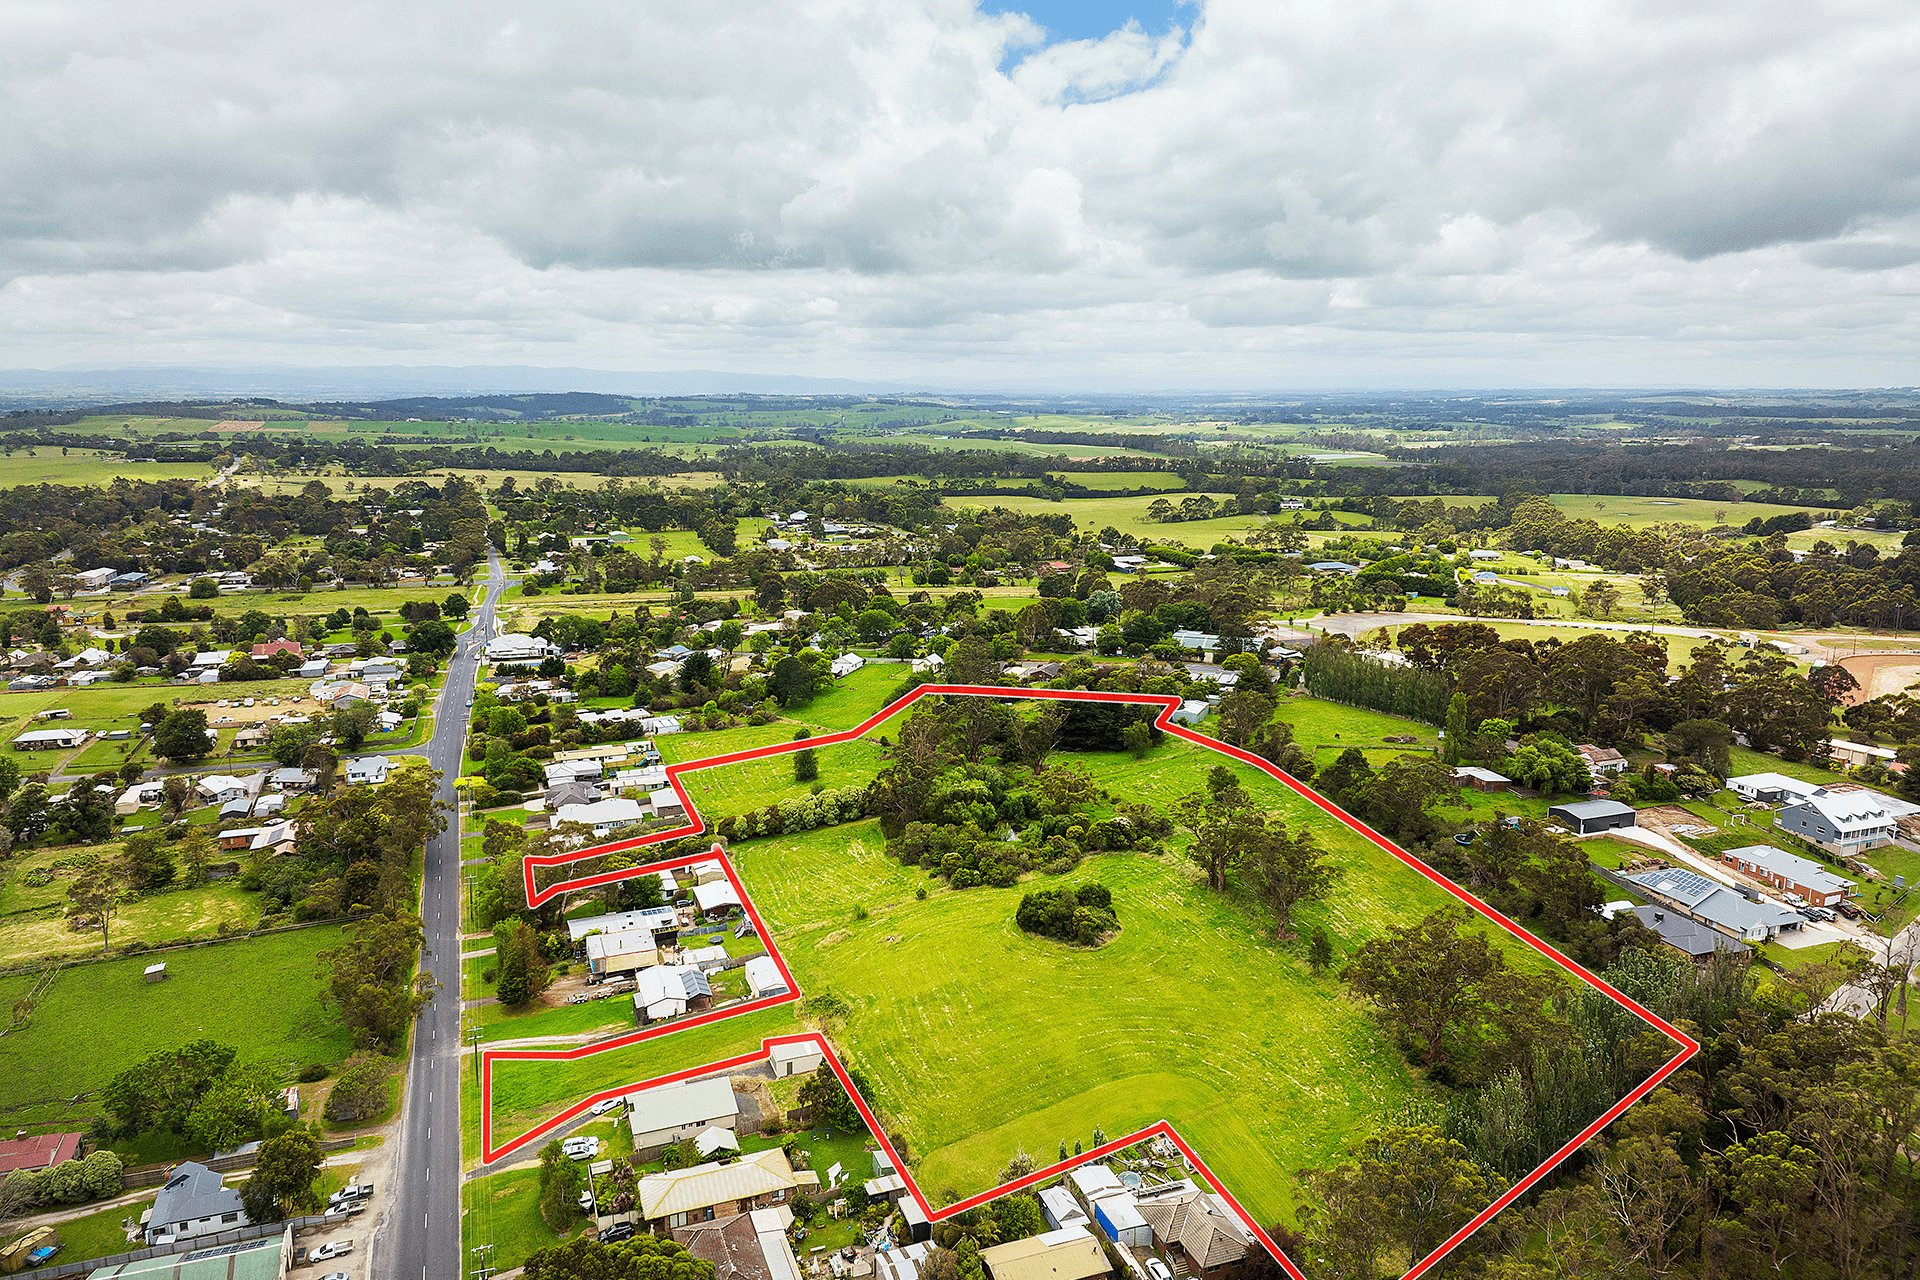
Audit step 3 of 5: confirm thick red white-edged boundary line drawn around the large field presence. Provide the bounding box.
[480,685,1699,1280]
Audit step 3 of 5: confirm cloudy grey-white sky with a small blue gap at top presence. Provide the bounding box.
[0,0,1920,388]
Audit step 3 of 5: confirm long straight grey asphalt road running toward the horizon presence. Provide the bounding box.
[367,557,505,1280]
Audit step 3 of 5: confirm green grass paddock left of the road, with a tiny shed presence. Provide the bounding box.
[0,925,351,1128]
